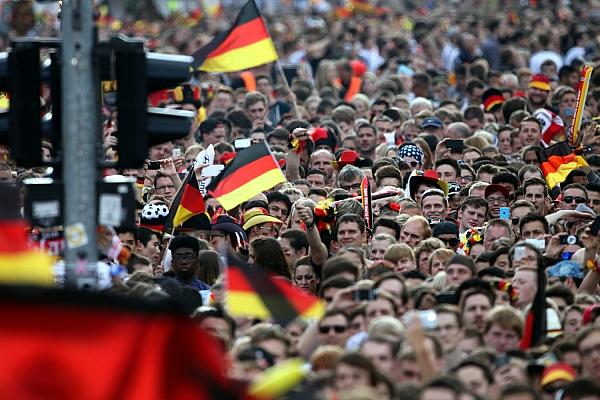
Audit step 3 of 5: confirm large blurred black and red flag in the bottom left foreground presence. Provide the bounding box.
[0,286,248,400]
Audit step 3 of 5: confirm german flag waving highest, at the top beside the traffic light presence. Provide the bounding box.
[192,0,279,72]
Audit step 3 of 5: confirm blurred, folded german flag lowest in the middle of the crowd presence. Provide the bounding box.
[226,255,325,327]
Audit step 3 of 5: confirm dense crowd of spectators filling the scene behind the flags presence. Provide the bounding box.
[5,1,600,400]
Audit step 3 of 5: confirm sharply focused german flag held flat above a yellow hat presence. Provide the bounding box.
[207,142,286,210]
